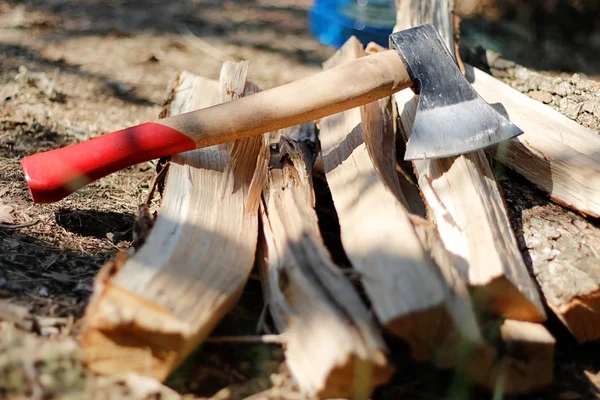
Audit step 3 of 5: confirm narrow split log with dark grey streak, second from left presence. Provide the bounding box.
[259,123,393,399]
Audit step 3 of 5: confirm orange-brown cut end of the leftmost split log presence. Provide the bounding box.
[81,261,185,380]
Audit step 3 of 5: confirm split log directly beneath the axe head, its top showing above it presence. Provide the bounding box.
[394,0,546,322]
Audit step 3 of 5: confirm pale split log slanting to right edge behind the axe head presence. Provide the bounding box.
[467,66,600,217]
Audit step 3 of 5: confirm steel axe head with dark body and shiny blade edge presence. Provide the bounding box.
[390,24,523,160]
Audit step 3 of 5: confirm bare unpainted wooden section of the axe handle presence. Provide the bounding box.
[156,50,412,147]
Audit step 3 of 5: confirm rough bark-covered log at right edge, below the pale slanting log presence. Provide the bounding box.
[501,173,600,343]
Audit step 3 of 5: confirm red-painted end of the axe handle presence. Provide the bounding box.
[21,122,196,203]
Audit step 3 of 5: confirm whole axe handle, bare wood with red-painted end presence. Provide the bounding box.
[21,50,412,203]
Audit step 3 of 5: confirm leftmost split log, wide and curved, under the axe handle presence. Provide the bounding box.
[82,63,267,380]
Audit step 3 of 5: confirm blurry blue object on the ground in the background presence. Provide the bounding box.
[308,0,396,48]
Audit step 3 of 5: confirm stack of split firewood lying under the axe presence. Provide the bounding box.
[75,0,600,398]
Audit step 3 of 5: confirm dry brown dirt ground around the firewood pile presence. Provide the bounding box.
[0,0,600,400]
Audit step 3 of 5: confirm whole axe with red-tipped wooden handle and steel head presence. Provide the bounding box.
[21,24,523,203]
